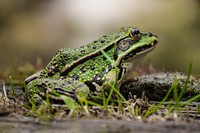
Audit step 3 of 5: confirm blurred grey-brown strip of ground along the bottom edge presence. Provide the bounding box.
[0,117,200,133]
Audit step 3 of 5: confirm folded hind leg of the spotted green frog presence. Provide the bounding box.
[25,78,89,104]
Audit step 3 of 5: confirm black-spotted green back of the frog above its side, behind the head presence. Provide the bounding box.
[40,33,119,78]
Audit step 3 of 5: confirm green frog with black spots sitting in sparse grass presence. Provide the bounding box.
[25,27,158,104]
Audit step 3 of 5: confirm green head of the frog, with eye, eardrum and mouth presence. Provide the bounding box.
[114,27,158,65]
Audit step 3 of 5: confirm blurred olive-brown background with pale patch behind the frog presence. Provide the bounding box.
[0,0,200,78]
